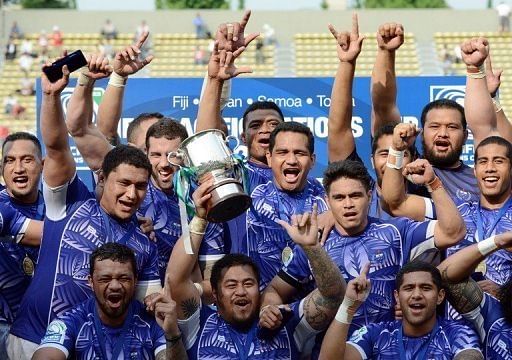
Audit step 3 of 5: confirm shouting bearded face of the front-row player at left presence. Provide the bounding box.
[89,259,136,323]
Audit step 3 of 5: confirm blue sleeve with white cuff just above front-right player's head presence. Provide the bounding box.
[395,218,436,264]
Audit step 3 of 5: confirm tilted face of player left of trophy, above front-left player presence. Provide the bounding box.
[100,164,149,221]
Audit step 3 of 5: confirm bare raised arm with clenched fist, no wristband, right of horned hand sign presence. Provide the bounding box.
[371,23,404,135]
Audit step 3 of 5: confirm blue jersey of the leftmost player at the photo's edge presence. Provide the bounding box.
[0,189,45,324]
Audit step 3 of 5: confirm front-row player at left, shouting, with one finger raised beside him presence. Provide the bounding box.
[33,243,187,360]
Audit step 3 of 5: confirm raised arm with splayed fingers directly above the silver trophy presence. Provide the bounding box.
[196,11,259,132]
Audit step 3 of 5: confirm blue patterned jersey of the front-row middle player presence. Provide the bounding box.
[178,301,318,360]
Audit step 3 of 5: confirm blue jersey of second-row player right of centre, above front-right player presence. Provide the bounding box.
[279,217,436,332]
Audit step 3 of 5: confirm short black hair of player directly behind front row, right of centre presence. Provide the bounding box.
[323,160,372,194]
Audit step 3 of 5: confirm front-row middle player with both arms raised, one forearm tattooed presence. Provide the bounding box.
[167,179,345,359]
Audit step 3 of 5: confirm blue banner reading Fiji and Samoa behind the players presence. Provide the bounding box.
[37,77,473,188]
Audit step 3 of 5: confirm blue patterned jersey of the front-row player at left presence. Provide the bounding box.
[39,298,166,360]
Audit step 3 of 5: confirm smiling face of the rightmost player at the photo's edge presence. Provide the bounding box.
[474,143,511,208]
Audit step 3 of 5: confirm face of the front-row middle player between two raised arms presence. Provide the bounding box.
[213,265,260,328]
